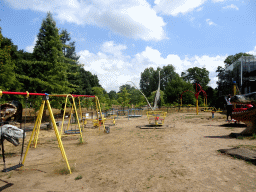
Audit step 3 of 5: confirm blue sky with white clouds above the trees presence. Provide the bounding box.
[0,0,256,92]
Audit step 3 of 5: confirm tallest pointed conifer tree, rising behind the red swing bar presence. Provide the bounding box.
[33,12,72,93]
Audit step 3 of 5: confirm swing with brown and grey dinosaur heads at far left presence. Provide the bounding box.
[0,91,29,172]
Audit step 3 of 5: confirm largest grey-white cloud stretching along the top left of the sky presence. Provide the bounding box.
[7,0,166,41]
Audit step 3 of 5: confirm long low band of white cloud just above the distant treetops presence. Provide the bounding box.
[78,41,227,92]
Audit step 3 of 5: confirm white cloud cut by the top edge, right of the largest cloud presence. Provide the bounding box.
[154,0,206,16]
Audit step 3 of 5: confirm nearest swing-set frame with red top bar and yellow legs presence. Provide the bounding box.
[0,90,106,174]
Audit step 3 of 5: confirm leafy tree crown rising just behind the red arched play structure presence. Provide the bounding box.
[181,67,210,90]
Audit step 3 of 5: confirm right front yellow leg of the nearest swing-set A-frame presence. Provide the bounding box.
[46,99,71,174]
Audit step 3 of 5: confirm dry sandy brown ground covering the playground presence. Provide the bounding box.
[0,112,256,192]
